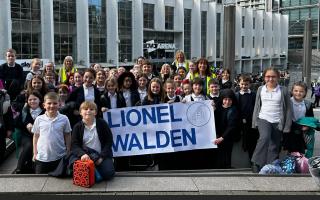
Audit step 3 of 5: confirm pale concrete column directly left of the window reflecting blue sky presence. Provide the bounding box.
[76,0,90,66]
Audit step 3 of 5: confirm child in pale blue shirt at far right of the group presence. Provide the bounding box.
[284,81,314,154]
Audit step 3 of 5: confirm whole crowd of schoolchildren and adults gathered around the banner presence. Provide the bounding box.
[0,49,313,179]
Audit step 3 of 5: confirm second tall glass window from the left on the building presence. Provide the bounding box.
[53,0,77,64]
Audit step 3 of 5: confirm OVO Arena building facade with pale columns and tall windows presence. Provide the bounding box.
[0,0,288,73]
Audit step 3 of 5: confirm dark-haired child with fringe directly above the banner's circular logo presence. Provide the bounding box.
[182,77,207,102]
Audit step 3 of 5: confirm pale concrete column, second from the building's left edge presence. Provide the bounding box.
[40,0,54,61]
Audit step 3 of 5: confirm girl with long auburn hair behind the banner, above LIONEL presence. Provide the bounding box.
[142,78,164,105]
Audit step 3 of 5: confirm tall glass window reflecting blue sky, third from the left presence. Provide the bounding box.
[88,0,107,63]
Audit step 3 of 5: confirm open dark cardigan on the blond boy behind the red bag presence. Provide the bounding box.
[71,118,113,159]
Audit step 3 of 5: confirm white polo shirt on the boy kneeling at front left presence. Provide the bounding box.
[31,113,71,162]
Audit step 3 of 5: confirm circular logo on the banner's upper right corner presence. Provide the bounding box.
[187,102,211,127]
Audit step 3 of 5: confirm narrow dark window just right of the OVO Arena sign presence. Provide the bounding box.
[184,9,191,59]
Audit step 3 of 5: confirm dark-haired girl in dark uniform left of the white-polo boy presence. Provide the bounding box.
[13,90,44,174]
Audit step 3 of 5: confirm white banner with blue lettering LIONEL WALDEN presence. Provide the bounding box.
[103,100,216,157]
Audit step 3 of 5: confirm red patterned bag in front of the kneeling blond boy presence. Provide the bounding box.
[73,160,95,188]
